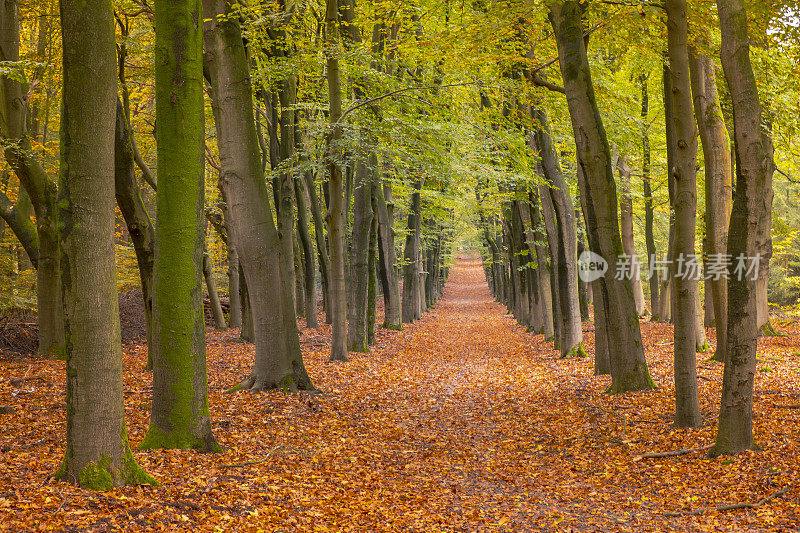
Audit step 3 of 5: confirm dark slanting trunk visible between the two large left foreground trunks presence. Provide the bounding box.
[114,99,156,370]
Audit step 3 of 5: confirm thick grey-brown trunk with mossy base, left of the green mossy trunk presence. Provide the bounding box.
[55,0,157,490]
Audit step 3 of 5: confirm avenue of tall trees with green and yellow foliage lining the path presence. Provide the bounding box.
[0,0,800,489]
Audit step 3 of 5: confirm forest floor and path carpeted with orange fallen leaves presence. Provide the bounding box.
[0,258,800,532]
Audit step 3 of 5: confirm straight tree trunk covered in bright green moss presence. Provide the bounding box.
[140,0,221,452]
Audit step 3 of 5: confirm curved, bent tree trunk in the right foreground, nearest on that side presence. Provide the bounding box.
[710,0,775,456]
